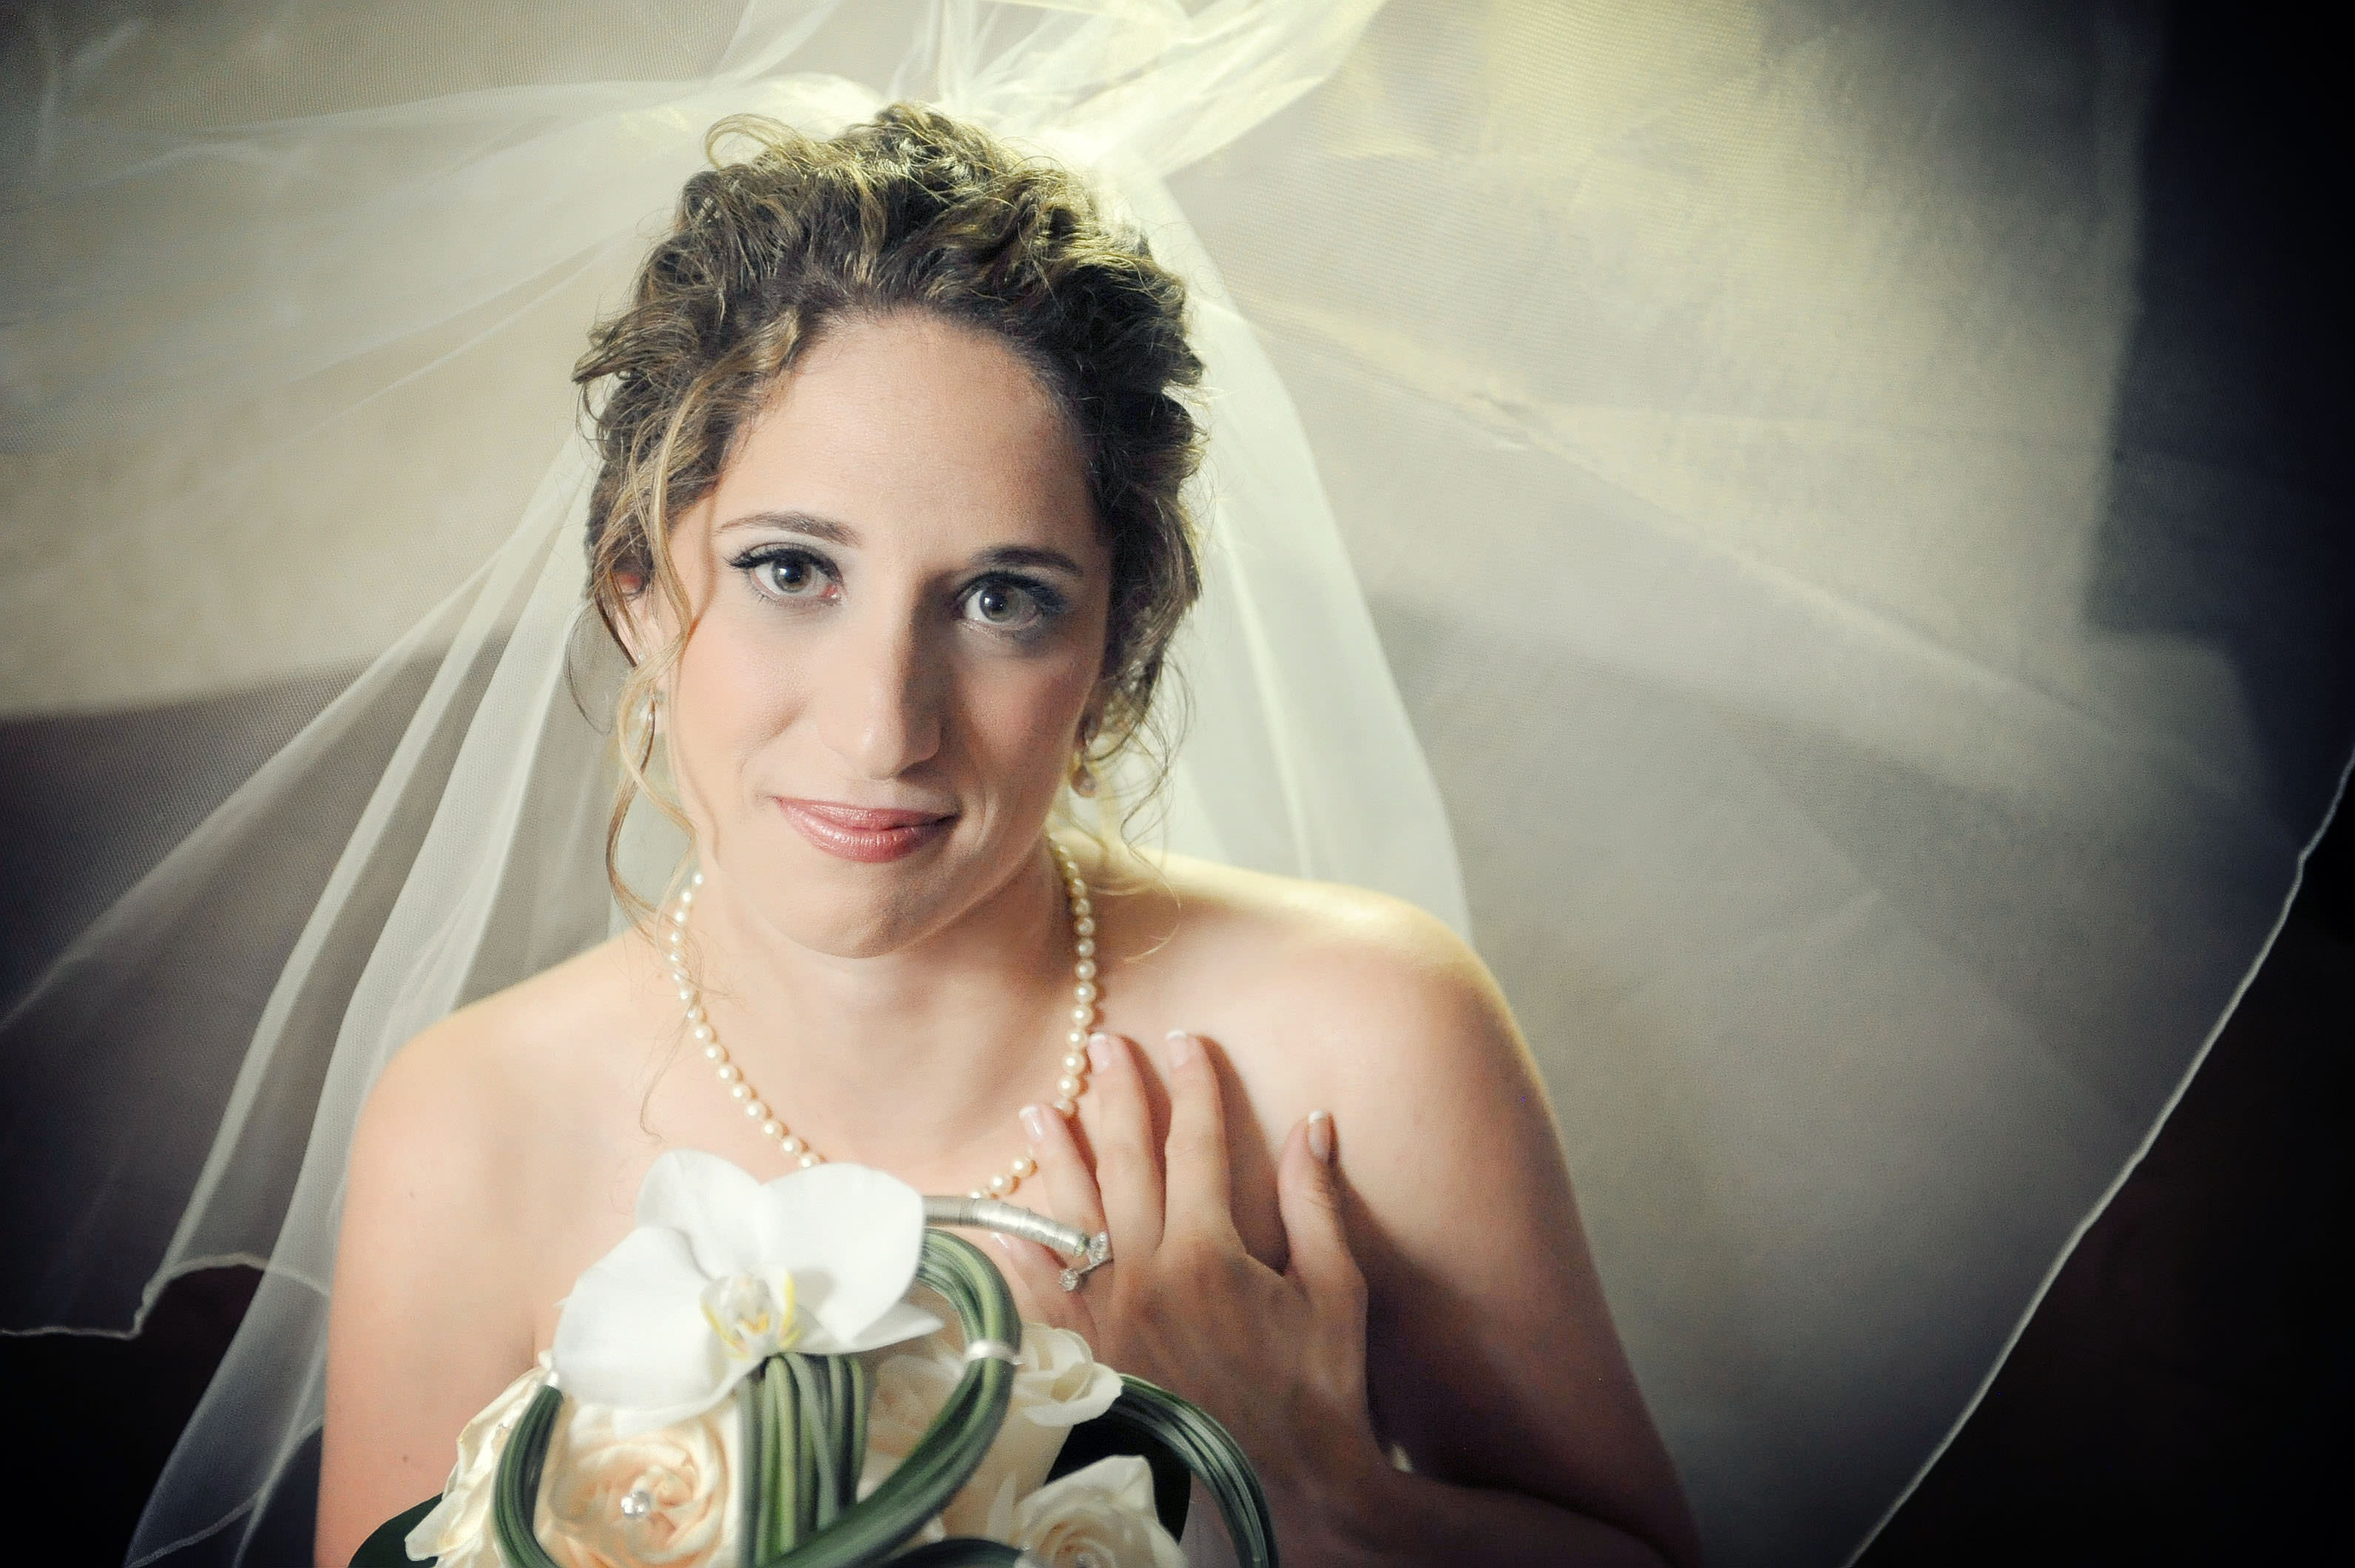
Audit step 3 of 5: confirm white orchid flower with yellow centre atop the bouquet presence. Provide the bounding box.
[553,1149,939,1434]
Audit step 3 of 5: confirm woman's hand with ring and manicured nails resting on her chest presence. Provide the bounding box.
[994,1031,1396,1561]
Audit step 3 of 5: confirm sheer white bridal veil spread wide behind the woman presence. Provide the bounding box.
[0,0,2345,1564]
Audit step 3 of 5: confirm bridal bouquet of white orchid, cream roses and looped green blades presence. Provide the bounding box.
[386,1152,1274,1568]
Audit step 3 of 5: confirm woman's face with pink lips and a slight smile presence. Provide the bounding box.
[666,313,1112,956]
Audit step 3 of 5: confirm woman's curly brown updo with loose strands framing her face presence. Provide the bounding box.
[572,104,1201,911]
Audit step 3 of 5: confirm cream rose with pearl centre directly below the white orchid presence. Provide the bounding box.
[533,1401,742,1568]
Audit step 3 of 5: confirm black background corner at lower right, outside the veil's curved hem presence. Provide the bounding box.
[1863,805,2355,1568]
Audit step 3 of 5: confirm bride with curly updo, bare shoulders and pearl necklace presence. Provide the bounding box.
[316,106,1695,1566]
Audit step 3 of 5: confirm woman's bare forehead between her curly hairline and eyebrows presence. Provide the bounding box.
[714,313,1100,561]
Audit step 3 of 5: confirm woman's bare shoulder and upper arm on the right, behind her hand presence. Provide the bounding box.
[1104,859,1693,1558]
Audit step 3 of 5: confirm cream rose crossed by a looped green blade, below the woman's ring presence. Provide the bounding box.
[859,1323,1121,1540]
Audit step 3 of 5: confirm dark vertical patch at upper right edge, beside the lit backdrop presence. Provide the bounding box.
[2089,4,2355,831]
